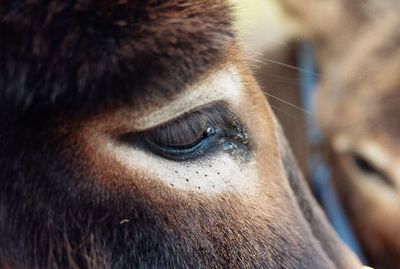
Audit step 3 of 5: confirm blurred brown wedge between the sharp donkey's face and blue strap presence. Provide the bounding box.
[254,46,310,178]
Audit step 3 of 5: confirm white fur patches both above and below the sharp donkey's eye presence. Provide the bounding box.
[103,66,257,194]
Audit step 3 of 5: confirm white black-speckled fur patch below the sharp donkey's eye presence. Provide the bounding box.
[108,139,257,194]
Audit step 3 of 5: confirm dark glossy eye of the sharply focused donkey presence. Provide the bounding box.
[120,104,247,161]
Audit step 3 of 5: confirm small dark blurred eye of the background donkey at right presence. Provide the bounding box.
[351,153,394,186]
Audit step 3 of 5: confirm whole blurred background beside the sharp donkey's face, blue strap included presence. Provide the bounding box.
[231,0,400,269]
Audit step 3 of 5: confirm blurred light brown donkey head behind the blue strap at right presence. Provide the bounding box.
[287,0,400,268]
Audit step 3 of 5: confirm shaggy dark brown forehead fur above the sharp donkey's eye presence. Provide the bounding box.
[0,0,233,115]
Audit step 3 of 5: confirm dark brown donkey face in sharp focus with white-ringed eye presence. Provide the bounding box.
[0,0,361,268]
